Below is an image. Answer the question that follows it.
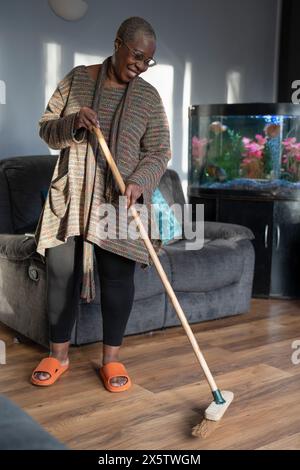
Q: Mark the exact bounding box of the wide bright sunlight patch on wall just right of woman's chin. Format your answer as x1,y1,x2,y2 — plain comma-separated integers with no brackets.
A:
141,64,174,142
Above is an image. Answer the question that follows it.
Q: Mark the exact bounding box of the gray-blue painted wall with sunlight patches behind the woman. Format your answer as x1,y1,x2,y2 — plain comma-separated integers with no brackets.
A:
0,0,278,194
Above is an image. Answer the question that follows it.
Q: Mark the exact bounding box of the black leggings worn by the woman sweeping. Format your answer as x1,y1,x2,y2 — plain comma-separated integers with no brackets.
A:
46,236,135,346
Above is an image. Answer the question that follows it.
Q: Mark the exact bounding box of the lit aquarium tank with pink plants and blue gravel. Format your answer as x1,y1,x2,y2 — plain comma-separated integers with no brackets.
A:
189,103,300,196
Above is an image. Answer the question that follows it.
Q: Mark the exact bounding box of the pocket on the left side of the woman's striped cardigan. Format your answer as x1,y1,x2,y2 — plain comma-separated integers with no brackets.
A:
49,173,71,219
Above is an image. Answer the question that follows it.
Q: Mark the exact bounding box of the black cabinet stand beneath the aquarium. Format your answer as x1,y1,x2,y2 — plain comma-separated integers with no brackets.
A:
189,188,300,299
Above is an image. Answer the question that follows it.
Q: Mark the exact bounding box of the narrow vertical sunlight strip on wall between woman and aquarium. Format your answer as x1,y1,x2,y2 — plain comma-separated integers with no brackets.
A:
181,62,192,175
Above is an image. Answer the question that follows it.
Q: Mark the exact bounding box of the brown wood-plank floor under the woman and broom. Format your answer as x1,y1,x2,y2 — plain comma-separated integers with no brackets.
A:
0,299,300,450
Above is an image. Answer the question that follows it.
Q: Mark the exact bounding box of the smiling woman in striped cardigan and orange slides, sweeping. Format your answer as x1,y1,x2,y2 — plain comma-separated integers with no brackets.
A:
31,17,170,392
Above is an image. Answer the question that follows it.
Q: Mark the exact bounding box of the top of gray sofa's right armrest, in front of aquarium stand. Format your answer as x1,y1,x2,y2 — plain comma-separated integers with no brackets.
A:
204,222,255,242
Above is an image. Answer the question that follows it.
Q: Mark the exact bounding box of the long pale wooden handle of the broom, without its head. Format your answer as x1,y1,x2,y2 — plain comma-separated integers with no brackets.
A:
93,127,218,392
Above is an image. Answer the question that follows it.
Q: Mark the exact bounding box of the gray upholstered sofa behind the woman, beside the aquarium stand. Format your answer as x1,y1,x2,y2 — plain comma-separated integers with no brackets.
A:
0,155,254,345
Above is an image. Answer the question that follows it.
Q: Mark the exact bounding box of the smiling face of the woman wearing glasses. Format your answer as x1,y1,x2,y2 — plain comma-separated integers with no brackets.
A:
113,32,156,83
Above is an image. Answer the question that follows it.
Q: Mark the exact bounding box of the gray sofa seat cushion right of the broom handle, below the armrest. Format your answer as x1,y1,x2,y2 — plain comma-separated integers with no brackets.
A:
163,240,244,292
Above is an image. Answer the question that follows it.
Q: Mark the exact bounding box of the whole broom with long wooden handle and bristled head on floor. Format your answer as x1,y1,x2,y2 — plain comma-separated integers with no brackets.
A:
93,127,233,437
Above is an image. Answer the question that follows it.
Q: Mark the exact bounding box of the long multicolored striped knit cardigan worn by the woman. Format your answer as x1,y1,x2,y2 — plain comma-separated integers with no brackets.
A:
35,60,170,302
